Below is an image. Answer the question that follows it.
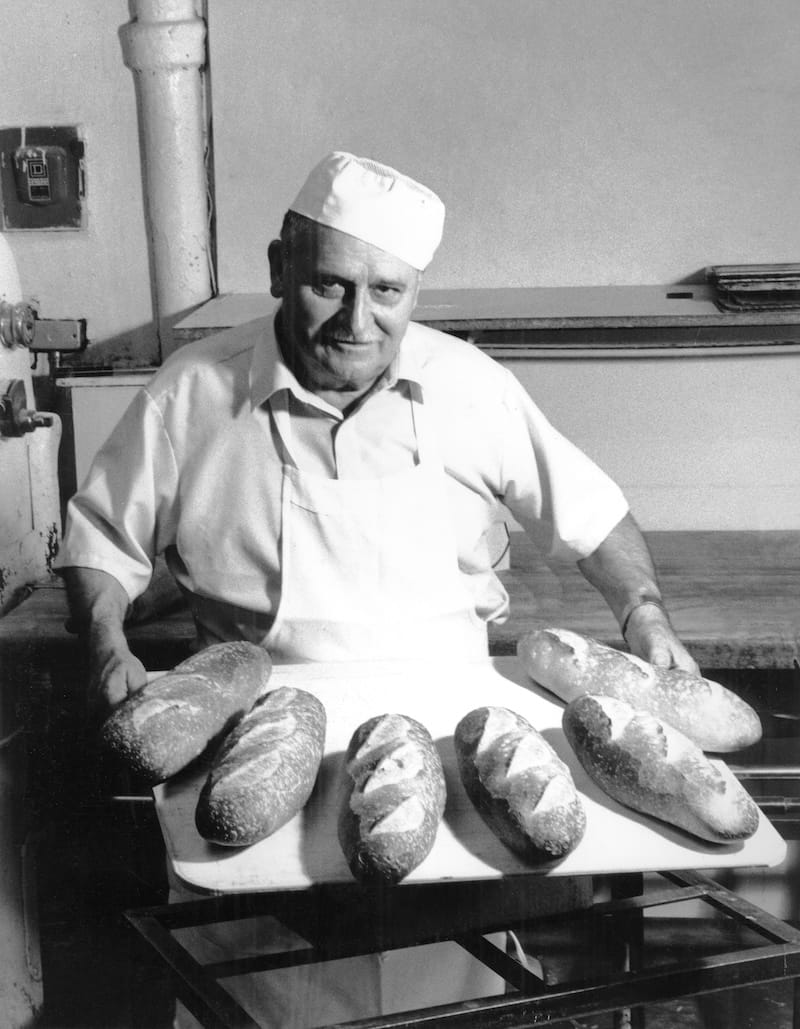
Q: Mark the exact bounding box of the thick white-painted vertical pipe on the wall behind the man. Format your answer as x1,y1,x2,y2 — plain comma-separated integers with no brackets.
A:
119,0,211,357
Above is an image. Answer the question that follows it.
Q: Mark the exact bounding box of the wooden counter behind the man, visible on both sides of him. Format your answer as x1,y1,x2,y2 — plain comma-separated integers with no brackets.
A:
0,532,800,677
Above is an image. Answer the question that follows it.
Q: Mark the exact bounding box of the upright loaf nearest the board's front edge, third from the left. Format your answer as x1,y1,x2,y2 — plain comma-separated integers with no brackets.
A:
339,714,446,883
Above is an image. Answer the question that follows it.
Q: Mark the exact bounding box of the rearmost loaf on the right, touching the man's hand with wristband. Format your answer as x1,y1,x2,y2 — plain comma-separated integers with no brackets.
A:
517,629,761,753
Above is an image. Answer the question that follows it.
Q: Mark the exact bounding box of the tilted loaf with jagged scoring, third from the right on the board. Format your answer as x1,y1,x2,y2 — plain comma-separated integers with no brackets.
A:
453,707,586,864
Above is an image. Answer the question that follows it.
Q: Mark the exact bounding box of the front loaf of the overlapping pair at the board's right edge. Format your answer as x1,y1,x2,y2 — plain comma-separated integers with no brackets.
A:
562,695,759,843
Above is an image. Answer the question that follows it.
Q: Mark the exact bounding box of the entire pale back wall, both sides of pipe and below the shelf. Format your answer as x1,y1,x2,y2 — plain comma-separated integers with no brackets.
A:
7,0,800,528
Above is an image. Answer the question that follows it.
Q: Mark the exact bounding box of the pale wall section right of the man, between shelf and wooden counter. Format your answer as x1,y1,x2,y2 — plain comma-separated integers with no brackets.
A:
509,354,800,530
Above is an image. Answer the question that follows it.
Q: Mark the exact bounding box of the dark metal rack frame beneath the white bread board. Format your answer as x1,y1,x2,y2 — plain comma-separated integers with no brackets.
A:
126,872,800,1029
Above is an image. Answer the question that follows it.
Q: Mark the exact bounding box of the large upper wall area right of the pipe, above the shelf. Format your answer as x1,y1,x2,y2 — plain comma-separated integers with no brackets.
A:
209,0,800,292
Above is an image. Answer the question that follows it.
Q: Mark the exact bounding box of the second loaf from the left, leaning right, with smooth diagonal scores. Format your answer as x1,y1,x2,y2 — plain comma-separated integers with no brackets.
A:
195,686,326,847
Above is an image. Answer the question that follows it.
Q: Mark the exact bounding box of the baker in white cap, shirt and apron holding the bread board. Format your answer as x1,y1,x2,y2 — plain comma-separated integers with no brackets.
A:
58,152,696,1025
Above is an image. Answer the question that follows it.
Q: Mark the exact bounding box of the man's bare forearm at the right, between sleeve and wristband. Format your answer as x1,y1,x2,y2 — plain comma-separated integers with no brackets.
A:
578,515,661,625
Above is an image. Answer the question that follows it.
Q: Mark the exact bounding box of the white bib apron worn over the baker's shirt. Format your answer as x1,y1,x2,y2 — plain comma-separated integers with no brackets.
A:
264,394,487,663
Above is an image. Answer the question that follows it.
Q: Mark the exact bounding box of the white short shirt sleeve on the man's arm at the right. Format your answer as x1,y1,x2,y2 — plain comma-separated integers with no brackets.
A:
501,376,628,561
